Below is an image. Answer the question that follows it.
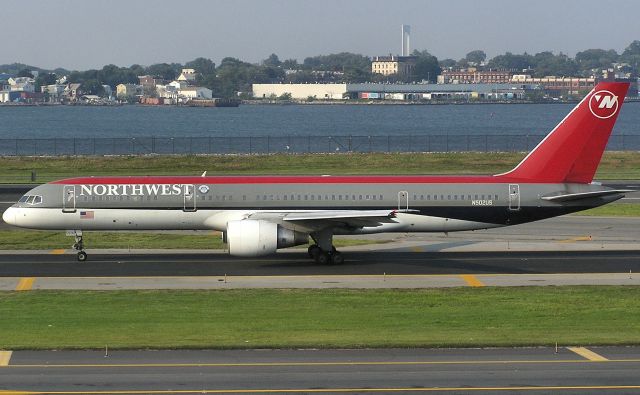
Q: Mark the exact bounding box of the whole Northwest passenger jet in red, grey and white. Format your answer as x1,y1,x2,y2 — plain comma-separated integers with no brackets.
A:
2,82,632,264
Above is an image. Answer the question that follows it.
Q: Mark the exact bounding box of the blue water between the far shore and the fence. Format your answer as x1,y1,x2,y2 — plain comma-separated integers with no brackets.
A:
0,102,640,139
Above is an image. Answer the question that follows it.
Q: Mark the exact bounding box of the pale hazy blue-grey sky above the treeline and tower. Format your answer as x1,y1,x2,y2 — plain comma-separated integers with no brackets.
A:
5,0,640,70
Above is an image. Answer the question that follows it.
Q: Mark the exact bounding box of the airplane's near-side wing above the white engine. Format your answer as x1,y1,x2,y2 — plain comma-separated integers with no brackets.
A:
247,210,406,230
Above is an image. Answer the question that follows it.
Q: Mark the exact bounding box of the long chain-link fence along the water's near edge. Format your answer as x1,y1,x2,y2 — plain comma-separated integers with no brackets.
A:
0,134,640,156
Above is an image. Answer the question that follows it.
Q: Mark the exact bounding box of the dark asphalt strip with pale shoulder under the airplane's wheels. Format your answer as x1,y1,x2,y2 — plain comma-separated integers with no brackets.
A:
0,251,640,290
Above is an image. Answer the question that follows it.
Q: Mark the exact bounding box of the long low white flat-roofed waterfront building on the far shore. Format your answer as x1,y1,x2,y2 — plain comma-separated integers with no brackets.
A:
253,83,536,101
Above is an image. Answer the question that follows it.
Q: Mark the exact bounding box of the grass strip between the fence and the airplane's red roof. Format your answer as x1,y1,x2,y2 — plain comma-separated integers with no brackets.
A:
0,152,640,183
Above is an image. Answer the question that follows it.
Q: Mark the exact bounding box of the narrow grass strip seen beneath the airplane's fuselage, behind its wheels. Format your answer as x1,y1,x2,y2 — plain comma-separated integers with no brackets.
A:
0,230,380,250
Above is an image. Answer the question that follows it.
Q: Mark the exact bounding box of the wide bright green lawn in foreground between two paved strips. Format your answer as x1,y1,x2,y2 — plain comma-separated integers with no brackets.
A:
0,286,640,350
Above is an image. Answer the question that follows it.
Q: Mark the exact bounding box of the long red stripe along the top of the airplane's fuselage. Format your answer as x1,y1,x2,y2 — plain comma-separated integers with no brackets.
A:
51,176,531,185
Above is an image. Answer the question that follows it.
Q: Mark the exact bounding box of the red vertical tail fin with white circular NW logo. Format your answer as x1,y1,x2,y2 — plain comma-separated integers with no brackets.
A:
500,82,629,183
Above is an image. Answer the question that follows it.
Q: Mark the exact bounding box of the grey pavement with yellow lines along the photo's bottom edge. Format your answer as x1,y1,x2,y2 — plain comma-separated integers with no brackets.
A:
0,347,640,395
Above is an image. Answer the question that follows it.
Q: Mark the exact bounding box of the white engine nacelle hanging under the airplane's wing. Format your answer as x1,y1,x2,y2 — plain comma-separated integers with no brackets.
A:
226,219,309,257
